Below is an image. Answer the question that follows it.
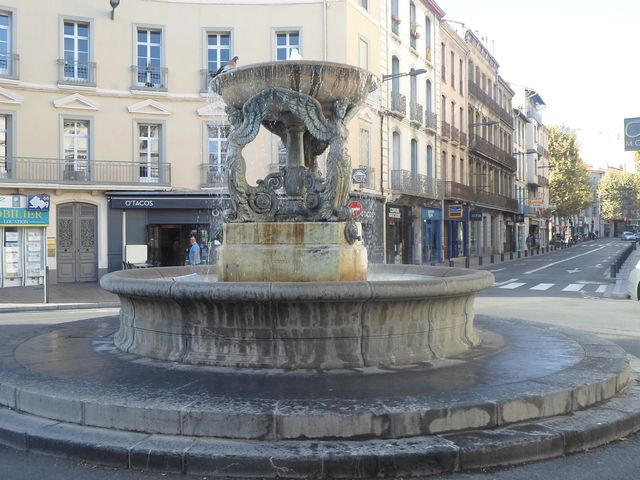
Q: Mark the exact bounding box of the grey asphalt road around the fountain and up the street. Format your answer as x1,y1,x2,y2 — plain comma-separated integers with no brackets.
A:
0,249,640,480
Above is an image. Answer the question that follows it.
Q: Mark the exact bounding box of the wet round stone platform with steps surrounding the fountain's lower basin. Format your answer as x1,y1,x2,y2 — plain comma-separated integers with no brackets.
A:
0,317,640,478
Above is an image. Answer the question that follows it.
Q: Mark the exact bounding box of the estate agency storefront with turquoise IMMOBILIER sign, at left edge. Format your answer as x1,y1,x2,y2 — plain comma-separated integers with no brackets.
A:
0,194,51,288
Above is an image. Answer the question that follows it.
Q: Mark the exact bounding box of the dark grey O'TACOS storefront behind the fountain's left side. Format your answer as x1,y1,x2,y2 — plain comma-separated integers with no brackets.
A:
107,192,231,271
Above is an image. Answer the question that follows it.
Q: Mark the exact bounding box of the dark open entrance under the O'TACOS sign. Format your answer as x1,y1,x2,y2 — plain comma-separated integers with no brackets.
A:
147,224,211,267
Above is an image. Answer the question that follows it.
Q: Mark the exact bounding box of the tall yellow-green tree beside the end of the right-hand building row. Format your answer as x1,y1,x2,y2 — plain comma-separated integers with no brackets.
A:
549,125,593,217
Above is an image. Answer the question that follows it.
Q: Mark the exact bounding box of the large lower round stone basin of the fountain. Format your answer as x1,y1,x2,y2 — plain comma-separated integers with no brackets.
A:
100,265,493,370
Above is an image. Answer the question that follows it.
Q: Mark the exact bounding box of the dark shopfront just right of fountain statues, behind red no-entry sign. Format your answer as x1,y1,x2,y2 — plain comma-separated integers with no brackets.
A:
348,195,384,263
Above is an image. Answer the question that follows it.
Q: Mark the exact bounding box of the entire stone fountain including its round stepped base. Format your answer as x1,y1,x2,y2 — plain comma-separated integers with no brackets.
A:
0,61,640,479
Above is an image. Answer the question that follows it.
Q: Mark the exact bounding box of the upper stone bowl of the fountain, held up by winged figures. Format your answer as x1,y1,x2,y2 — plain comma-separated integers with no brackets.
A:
211,60,379,109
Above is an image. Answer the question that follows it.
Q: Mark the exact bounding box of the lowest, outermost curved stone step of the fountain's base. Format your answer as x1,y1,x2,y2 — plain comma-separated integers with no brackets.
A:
0,381,640,479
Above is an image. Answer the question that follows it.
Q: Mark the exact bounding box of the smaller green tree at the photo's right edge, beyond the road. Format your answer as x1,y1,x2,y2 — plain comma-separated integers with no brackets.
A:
598,170,640,220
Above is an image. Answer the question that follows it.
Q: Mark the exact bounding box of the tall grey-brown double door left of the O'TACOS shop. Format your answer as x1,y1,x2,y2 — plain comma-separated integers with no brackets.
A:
56,203,98,283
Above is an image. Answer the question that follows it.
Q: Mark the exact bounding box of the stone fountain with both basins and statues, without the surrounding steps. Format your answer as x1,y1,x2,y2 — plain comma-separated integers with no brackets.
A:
102,61,493,370
